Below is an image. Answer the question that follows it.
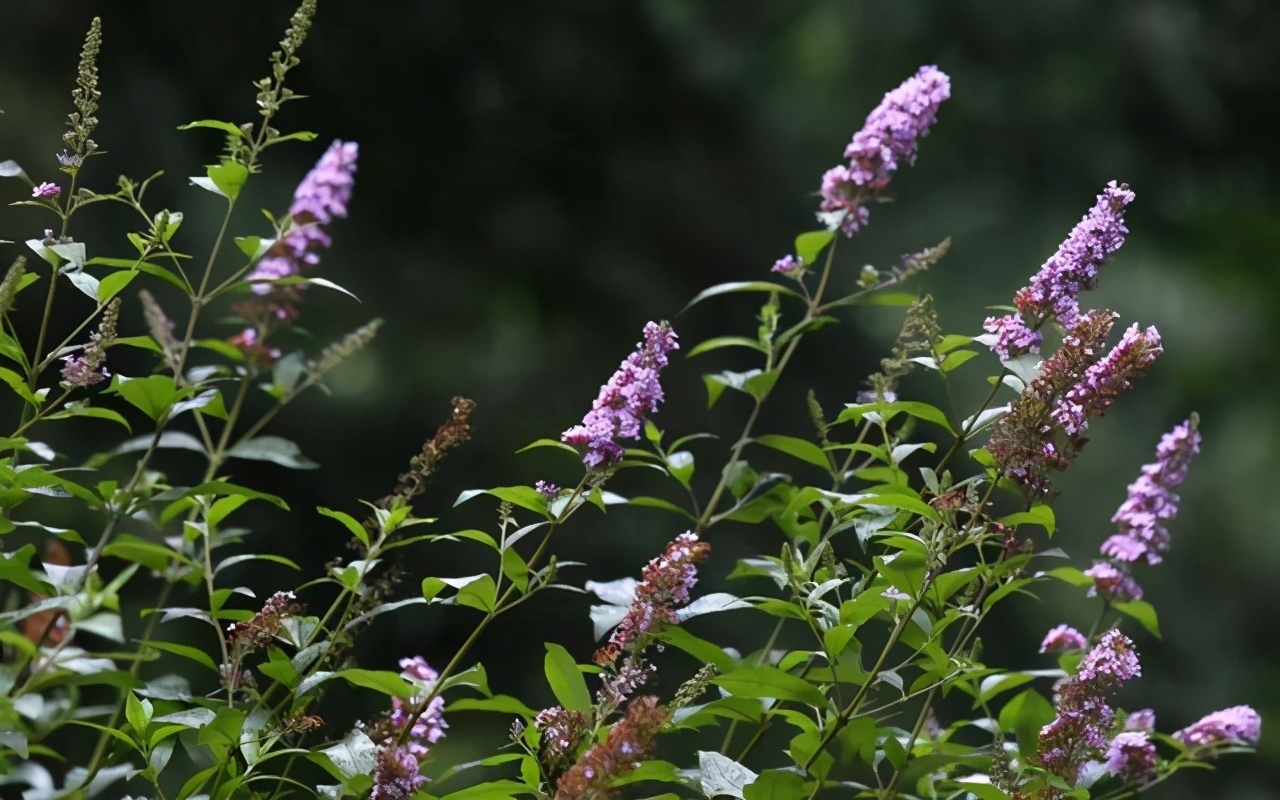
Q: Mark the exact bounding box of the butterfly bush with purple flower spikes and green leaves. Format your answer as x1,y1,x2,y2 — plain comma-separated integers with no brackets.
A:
0,0,1261,800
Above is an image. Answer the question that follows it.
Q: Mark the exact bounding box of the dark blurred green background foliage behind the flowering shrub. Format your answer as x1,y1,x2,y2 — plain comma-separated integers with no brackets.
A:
0,0,1280,797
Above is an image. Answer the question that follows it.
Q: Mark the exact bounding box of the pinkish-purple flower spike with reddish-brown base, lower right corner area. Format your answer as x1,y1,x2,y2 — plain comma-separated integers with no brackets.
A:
1036,630,1142,797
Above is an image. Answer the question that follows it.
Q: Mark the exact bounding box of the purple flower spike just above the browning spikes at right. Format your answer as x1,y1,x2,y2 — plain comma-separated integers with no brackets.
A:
1014,180,1134,330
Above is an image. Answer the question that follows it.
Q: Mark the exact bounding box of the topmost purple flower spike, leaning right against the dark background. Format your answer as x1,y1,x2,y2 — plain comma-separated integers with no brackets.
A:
819,65,951,234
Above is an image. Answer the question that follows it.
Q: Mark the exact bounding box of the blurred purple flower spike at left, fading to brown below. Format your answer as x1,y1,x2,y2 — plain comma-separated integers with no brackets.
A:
234,140,360,356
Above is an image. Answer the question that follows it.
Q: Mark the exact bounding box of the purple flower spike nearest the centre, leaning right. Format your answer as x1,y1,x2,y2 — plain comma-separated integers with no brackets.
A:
561,323,680,470
